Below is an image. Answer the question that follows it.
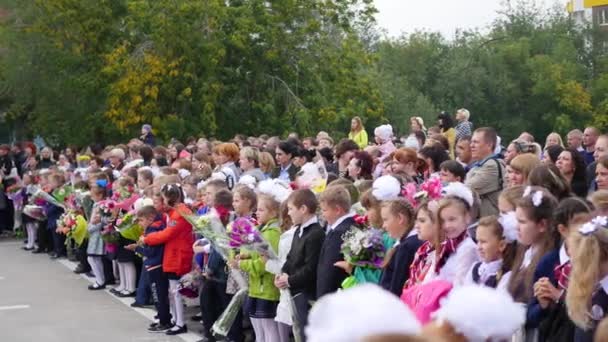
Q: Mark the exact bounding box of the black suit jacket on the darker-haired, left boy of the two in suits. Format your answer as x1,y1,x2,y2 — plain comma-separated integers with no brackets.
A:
282,223,325,298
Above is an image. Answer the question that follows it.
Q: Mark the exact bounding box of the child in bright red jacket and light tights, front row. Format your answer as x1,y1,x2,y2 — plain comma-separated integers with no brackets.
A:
140,184,194,335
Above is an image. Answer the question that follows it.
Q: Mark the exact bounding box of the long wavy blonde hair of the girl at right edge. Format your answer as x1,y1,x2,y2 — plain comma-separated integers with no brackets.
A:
566,227,608,329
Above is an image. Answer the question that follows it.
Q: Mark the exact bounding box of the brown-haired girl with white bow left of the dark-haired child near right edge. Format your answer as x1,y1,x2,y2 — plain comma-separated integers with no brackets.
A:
508,187,558,303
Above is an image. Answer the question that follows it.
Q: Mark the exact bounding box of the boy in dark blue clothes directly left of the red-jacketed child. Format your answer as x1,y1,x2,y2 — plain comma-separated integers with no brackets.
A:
125,206,171,332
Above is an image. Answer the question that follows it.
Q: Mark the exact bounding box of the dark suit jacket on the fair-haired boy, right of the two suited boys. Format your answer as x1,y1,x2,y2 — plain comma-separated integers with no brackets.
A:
317,217,355,299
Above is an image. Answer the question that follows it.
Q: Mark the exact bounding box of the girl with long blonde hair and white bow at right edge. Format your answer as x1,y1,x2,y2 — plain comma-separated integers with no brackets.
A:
566,216,608,342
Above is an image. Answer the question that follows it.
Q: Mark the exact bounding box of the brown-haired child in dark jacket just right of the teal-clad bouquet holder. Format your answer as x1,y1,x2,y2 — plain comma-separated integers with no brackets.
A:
380,199,422,296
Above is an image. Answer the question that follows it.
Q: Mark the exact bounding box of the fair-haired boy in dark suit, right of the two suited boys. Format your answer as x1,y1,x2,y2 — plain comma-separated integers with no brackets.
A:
317,186,355,299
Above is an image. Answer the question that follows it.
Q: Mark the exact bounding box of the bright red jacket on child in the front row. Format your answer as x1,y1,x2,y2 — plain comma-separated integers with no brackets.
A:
144,204,194,276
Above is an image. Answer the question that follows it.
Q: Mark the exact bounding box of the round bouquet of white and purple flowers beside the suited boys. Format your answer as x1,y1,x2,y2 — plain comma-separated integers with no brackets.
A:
341,227,386,268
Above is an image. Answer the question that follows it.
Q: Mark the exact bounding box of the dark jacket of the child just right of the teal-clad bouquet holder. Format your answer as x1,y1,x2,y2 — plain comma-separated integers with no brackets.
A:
380,230,422,297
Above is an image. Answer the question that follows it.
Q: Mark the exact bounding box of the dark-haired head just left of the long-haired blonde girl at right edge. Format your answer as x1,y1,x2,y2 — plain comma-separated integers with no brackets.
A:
553,197,592,243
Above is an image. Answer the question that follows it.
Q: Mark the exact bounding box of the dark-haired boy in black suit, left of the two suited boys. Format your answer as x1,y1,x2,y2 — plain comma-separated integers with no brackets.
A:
275,190,325,341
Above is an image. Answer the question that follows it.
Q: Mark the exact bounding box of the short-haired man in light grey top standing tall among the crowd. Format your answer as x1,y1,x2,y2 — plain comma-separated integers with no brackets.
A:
465,127,505,217
